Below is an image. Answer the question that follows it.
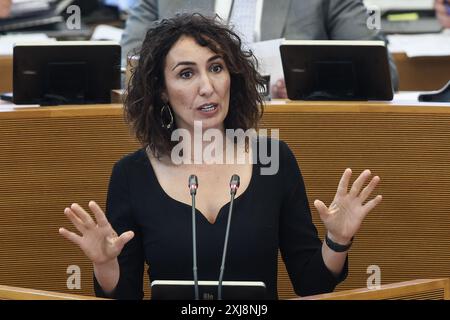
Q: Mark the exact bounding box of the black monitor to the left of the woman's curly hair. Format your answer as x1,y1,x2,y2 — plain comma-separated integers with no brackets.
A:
13,41,121,105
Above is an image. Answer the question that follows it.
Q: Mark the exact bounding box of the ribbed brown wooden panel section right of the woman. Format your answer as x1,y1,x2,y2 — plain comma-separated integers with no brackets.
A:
264,112,450,294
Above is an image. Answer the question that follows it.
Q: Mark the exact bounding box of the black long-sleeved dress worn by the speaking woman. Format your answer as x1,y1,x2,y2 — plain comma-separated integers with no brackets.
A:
94,141,348,299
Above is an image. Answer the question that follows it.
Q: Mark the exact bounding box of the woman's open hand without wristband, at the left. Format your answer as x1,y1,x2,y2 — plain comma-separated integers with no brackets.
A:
59,201,134,265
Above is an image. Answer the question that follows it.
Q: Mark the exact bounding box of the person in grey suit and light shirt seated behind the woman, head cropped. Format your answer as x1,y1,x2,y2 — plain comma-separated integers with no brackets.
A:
121,0,398,98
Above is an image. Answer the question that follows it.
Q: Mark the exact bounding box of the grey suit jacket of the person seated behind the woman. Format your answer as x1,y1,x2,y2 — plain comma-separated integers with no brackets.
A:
122,0,398,89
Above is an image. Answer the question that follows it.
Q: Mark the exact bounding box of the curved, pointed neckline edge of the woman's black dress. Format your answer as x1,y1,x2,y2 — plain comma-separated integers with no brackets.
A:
141,148,257,226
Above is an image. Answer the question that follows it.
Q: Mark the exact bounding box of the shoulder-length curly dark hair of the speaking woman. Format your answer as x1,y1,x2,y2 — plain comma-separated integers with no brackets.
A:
124,13,264,157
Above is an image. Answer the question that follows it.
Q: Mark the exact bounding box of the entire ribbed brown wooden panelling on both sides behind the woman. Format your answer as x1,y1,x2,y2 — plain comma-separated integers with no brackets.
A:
0,103,450,298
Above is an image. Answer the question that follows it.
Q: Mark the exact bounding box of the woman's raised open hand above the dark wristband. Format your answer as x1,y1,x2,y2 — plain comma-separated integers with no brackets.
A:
314,169,382,244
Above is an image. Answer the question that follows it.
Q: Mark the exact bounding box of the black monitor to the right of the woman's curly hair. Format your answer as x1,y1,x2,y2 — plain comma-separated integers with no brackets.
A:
280,40,393,100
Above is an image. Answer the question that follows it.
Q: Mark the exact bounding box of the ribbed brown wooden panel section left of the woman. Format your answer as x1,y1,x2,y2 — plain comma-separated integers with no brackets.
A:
0,117,142,294
